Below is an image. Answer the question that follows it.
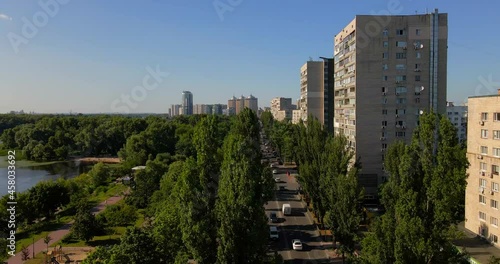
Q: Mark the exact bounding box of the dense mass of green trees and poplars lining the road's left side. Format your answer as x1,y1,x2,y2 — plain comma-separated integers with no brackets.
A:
82,109,276,264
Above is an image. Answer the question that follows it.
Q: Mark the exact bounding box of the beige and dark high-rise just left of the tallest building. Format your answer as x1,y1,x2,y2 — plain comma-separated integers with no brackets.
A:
298,58,334,132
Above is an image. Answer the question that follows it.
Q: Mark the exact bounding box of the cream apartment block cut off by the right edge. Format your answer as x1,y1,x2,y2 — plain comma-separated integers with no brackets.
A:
465,89,500,248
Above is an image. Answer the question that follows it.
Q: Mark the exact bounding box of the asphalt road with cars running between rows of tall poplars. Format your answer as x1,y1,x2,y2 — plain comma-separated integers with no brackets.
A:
265,169,341,264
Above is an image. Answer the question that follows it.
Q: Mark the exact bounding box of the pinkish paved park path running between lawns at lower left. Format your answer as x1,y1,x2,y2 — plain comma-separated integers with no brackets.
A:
6,196,123,264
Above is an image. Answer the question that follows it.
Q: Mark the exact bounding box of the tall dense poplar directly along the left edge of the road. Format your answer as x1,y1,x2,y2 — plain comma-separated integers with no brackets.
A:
216,134,268,264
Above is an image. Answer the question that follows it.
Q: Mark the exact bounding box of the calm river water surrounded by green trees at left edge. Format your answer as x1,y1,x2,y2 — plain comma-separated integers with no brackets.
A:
0,156,94,196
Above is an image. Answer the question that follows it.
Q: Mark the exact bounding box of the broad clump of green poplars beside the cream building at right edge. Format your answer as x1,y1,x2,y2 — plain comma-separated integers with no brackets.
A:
363,113,469,263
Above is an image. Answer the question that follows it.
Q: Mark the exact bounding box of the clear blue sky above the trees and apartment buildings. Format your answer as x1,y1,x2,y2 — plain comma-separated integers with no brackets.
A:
0,0,500,113
